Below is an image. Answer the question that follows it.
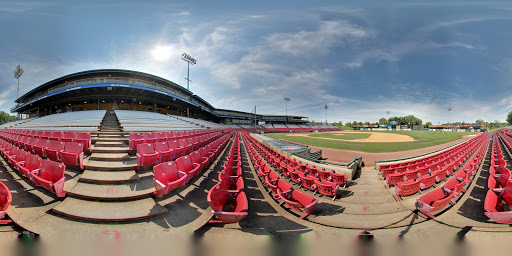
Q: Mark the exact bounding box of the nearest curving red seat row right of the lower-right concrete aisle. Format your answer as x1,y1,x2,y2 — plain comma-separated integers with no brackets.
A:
416,133,490,218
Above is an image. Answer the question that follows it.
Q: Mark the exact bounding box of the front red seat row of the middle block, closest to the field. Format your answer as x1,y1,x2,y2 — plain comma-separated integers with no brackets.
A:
244,132,347,200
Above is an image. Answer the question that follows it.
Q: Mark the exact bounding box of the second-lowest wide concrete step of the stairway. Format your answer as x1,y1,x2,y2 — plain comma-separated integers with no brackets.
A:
68,176,155,201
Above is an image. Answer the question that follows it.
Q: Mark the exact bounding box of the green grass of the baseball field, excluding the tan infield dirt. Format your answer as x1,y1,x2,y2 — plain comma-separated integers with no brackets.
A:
266,131,477,153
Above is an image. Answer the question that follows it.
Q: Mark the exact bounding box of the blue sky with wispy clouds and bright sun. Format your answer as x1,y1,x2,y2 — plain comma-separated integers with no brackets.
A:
0,0,512,124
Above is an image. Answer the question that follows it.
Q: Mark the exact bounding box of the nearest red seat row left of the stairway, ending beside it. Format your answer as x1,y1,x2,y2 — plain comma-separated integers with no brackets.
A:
0,140,66,197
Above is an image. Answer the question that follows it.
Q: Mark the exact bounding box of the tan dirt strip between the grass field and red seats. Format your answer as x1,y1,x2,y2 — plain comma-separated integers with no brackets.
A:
309,135,469,166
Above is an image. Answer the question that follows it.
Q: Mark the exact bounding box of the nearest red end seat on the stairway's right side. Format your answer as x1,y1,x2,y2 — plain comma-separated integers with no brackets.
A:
153,161,188,198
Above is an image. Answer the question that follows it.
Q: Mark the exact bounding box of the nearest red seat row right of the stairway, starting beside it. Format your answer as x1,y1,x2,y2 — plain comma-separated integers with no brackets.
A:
153,131,233,198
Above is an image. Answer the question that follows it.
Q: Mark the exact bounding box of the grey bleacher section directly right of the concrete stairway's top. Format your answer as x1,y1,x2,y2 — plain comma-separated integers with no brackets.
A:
115,110,226,132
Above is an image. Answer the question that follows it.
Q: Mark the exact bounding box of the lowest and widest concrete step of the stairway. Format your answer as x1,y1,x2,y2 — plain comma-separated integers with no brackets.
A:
52,197,167,222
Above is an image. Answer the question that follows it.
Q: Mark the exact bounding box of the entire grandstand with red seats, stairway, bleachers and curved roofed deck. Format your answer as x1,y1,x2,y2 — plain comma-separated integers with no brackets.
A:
0,70,512,249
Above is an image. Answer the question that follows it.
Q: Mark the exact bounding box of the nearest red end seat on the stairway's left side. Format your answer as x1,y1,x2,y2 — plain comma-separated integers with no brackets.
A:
32,160,66,197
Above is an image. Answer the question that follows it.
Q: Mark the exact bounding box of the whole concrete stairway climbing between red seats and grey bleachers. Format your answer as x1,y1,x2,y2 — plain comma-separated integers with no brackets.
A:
53,112,167,221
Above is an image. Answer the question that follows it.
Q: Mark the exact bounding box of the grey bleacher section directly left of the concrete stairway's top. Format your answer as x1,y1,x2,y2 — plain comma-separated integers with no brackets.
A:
2,110,106,131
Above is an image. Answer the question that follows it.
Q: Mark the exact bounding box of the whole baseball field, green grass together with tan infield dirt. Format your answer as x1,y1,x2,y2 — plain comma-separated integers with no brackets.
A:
267,131,477,153
